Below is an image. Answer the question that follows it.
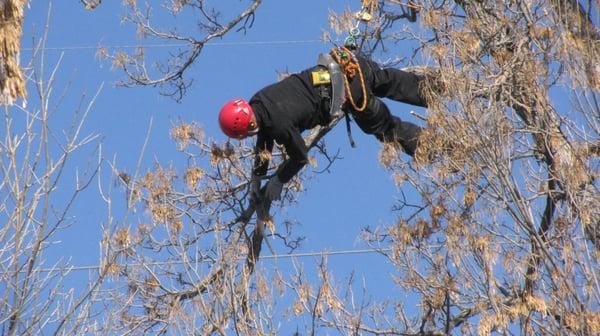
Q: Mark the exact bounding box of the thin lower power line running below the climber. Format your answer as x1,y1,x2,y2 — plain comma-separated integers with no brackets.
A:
7,248,392,275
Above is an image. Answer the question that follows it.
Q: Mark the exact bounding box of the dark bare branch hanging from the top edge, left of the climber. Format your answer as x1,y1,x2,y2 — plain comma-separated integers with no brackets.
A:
99,0,262,100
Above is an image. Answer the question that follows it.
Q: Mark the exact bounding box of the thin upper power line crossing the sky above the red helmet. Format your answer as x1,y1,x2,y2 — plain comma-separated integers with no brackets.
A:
21,39,326,51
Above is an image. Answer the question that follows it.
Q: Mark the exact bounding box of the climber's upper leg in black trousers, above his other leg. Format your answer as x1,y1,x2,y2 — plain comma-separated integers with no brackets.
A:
363,58,427,107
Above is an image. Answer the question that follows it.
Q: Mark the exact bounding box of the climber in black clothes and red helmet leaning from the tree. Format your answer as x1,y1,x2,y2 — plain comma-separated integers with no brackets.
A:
219,49,427,201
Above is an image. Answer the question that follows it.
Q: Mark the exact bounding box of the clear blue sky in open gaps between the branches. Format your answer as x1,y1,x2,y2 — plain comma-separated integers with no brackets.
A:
22,0,426,316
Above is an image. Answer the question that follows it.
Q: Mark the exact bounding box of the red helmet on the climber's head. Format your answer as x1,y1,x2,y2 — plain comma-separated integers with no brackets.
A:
219,98,254,139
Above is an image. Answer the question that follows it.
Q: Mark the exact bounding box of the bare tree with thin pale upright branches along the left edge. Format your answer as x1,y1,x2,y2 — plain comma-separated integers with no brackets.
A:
0,20,106,335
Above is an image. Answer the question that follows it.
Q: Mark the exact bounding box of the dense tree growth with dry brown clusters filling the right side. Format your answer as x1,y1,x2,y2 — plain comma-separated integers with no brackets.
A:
324,1,600,335
